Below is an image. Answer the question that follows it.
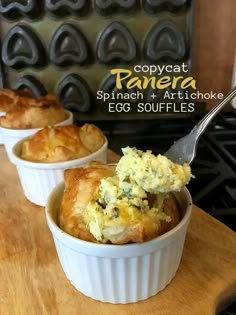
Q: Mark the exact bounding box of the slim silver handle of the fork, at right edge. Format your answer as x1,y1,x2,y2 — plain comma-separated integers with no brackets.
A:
191,86,236,138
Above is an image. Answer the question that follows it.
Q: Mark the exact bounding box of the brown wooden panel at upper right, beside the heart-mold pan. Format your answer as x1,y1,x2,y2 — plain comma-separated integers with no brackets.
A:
192,0,236,110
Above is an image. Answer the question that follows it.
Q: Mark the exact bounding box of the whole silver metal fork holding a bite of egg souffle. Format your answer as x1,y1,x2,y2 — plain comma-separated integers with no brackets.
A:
164,87,236,164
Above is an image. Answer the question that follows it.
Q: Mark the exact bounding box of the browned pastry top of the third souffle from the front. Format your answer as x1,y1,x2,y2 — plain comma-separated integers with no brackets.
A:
0,94,66,129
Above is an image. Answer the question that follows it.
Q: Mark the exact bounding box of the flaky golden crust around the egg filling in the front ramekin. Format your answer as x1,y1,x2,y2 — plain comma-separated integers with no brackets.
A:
59,163,180,244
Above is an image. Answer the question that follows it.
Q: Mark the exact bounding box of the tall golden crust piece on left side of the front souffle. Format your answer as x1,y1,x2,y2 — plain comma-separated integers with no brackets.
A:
59,162,114,243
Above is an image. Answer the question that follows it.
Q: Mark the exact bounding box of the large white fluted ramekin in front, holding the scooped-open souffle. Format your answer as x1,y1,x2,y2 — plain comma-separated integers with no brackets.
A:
46,182,192,304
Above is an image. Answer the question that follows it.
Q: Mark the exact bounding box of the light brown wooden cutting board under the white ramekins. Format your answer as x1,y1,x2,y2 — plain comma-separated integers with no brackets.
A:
0,147,236,315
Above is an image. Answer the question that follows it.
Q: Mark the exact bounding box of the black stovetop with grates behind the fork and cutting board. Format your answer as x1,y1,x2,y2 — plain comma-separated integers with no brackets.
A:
90,111,236,231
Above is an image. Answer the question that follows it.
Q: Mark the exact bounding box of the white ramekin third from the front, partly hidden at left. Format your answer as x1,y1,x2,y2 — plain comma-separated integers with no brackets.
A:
1,110,73,163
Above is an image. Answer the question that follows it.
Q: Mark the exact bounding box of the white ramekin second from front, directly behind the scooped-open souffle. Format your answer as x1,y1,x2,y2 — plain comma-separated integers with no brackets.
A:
12,138,108,207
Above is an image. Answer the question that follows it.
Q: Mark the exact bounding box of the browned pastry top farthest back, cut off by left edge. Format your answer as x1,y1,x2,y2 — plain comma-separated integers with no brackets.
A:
0,89,32,112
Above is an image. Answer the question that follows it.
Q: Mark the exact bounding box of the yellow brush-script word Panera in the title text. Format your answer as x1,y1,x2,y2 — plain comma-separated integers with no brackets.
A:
111,69,196,90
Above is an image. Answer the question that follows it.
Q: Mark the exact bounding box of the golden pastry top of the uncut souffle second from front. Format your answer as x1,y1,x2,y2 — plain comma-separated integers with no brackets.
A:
21,124,105,163
